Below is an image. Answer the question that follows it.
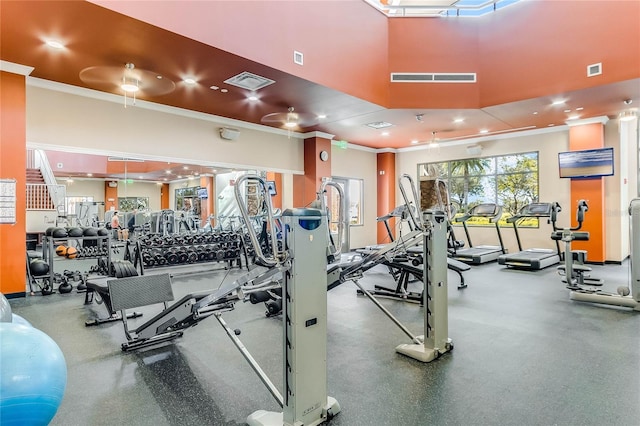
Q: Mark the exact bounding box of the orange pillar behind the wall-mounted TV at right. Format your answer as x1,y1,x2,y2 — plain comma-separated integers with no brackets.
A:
569,118,606,263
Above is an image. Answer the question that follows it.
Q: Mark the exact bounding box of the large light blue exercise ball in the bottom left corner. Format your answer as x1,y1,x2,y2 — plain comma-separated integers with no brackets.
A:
0,322,67,426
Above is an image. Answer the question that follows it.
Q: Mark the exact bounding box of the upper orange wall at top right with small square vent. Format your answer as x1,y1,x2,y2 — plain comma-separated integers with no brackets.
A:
478,1,640,106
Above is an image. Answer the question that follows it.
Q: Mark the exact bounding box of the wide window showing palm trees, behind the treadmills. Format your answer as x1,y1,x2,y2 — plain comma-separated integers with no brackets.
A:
418,152,538,227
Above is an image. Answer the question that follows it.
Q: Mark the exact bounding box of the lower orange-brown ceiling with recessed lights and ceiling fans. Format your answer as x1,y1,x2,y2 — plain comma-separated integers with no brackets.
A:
0,0,640,181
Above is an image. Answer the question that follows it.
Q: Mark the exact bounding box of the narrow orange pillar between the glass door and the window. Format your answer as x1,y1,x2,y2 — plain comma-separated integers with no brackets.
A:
377,152,396,244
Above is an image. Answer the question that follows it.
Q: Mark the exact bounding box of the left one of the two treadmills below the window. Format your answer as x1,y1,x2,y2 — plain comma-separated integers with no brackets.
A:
452,203,506,265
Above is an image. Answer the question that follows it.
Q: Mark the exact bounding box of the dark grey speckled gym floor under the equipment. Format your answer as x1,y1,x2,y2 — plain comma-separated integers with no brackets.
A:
11,255,640,426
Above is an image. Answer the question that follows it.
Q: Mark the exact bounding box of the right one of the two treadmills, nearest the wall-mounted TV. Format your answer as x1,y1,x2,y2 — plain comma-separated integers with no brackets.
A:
498,203,560,270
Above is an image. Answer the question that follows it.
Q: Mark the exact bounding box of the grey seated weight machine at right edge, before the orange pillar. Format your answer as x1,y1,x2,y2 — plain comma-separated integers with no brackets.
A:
553,198,640,311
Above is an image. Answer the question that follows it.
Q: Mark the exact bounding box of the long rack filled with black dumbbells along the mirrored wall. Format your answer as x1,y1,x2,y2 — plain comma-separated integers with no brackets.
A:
130,232,248,275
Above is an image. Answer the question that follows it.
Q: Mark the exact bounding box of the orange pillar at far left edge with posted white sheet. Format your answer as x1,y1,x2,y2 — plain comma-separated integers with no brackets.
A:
0,71,27,298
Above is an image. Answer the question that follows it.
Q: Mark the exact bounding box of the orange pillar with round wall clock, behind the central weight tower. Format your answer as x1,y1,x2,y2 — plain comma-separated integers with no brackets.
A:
293,136,331,207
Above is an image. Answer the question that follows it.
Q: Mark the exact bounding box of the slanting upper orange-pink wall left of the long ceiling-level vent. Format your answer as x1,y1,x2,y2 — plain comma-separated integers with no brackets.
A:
92,0,389,104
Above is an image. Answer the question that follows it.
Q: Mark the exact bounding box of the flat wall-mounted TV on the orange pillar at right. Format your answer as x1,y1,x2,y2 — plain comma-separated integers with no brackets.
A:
558,148,613,179
